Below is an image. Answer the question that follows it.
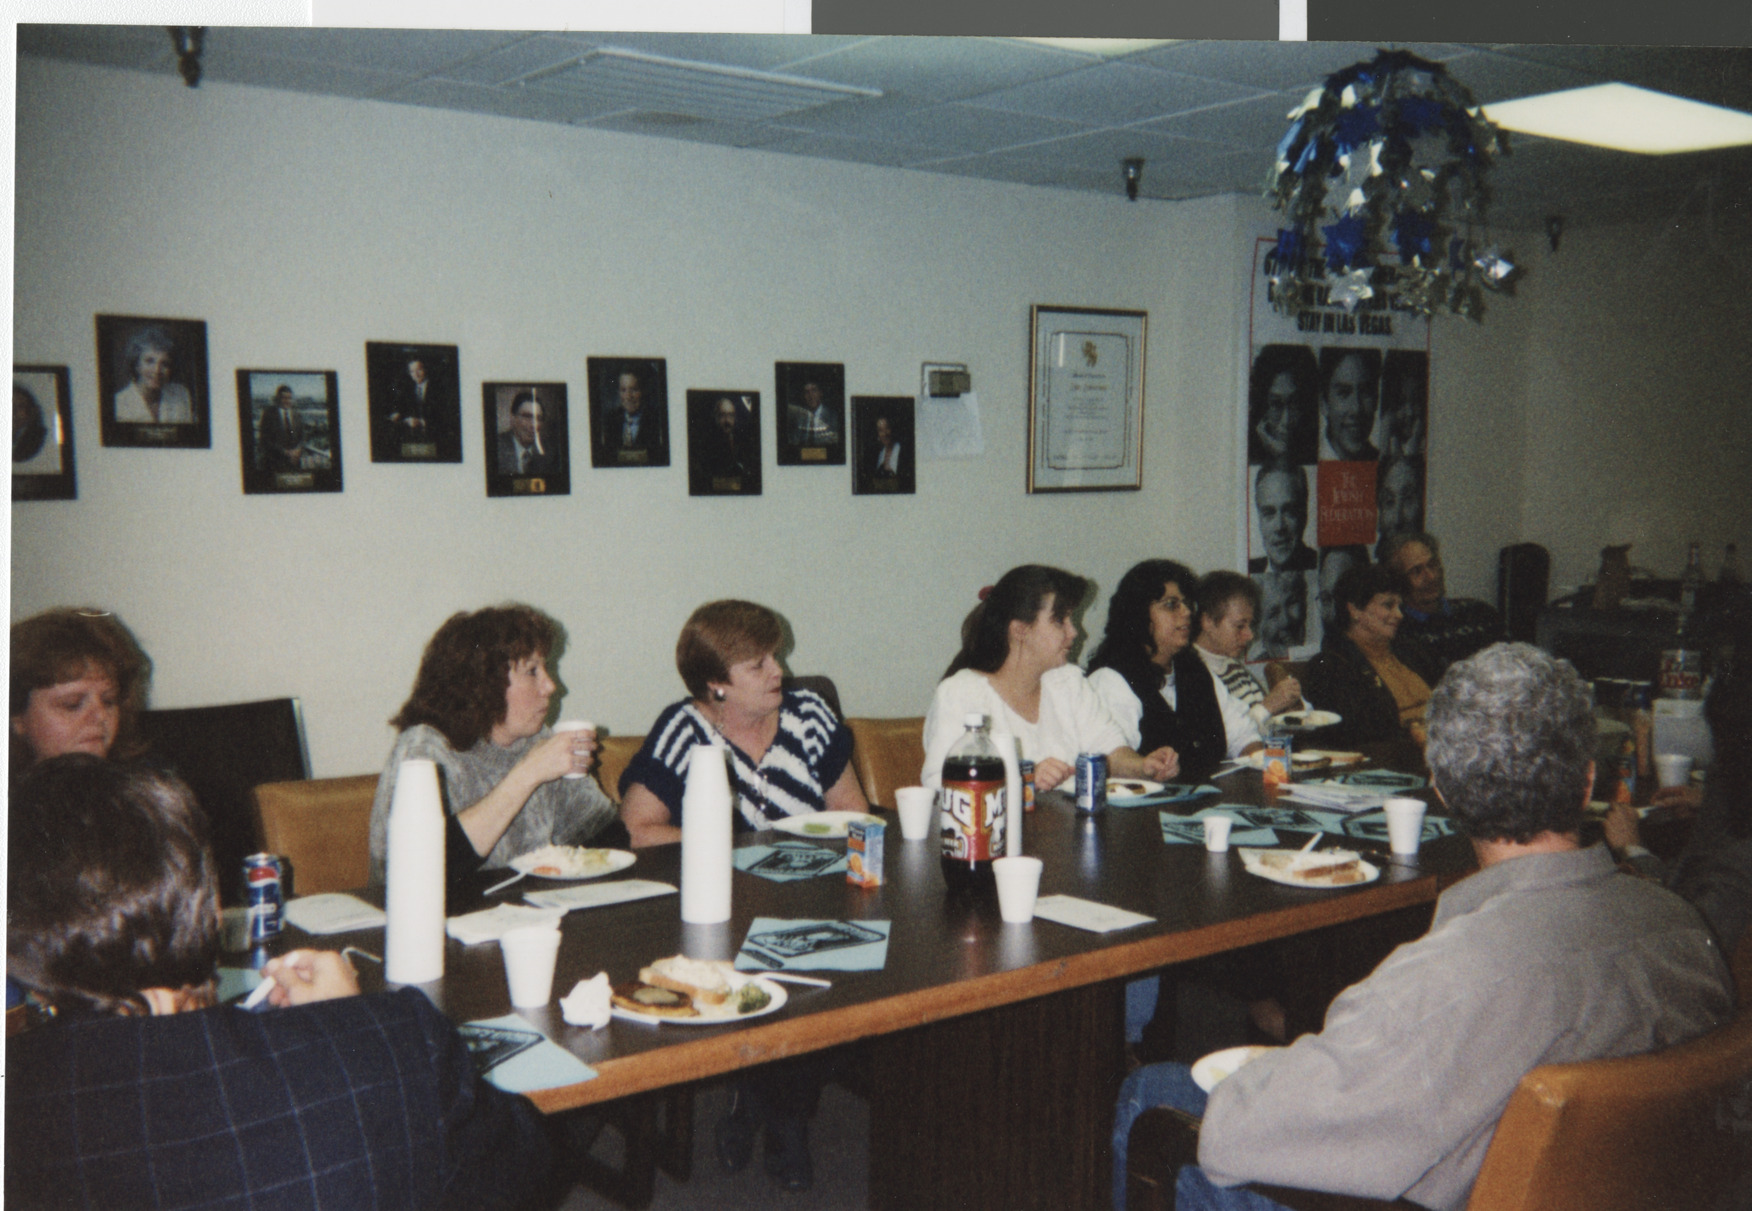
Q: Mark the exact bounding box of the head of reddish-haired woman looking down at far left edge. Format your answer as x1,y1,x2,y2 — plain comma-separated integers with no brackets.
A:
11,608,152,778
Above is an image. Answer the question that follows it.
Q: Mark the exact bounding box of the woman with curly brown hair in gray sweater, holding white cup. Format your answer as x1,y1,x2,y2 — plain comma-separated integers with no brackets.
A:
371,605,622,883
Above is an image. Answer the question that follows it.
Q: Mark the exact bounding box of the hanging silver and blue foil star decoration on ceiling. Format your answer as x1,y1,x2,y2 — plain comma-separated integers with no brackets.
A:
1267,51,1515,321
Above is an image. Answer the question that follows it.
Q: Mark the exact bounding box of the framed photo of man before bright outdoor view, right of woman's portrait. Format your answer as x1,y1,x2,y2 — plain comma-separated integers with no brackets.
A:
237,370,340,496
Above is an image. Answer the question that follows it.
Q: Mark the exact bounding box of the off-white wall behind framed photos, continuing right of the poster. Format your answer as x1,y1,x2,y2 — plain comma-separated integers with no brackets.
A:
12,60,1752,775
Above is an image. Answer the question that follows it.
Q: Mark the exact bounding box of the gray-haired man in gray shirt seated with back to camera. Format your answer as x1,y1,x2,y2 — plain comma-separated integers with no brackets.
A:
1113,643,1733,1211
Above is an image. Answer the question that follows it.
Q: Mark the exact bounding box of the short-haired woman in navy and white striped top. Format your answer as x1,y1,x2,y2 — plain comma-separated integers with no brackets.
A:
620,601,869,846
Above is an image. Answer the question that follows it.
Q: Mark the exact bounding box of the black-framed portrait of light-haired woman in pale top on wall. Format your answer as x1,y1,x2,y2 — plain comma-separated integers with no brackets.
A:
96,315,212,450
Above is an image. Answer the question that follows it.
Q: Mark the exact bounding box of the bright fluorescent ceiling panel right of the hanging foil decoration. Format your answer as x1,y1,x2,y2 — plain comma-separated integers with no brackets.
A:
1484,84,1752,156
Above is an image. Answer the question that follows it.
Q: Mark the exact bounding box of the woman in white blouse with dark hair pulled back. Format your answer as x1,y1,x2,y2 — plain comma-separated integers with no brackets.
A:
920,564,1179,790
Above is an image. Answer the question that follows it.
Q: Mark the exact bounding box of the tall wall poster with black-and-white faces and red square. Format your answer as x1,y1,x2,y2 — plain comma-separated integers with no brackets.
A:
1244,237,1430,661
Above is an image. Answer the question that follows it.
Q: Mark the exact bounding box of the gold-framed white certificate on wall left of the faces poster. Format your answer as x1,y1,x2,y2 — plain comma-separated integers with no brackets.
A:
1028,305,1149,492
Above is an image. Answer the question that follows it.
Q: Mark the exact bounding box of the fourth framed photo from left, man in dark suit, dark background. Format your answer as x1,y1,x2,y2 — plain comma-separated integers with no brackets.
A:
364,340,463,463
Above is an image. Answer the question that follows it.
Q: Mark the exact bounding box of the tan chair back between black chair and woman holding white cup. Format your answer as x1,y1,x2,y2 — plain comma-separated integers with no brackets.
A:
254,773,377,896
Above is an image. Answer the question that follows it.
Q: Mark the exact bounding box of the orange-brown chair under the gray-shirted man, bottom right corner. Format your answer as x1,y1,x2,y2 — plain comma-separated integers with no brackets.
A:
1127,936,1752,1211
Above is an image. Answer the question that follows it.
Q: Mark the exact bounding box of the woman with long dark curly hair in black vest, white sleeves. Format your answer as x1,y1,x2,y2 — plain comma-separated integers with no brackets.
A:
1090,559,1260,782
